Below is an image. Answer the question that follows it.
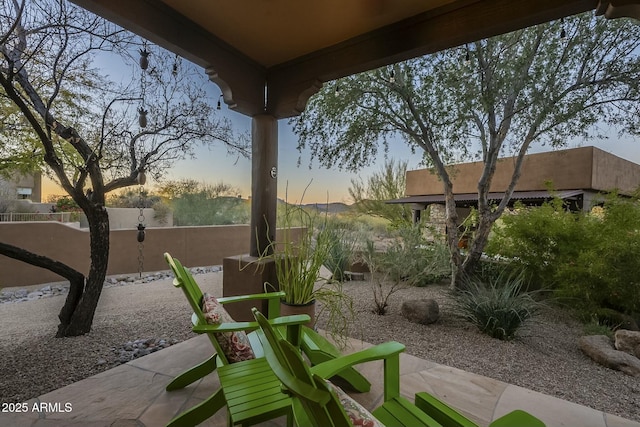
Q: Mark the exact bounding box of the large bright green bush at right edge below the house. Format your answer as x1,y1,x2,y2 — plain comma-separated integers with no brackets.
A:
487,194,640,318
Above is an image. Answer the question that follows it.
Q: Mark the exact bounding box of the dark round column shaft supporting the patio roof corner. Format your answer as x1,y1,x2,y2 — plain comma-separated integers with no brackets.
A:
249,114,278,257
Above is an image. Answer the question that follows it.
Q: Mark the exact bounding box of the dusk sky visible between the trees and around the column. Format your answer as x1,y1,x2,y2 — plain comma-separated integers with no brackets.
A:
43,46,640,204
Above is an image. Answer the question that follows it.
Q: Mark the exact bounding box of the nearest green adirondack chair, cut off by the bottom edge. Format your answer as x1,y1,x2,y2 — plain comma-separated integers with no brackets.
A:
253,308,544,427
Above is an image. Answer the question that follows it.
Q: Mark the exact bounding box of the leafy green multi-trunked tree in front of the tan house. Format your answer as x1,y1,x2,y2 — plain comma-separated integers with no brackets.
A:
294,14,640,286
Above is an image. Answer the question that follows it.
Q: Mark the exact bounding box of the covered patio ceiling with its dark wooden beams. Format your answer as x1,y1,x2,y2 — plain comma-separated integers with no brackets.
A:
67,0,640,119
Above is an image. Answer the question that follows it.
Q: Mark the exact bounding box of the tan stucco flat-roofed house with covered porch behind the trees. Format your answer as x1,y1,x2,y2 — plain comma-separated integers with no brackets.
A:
388,147,640,226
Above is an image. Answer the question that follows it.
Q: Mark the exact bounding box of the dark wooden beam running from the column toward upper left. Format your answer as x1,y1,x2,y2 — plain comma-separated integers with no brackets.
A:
71,0,266,116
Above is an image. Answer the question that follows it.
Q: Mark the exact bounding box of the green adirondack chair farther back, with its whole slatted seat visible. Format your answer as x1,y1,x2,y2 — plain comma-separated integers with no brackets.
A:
164,253,370,427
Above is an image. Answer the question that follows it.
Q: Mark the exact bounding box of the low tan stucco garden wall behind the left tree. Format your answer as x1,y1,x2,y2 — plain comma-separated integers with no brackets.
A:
0,222,301,286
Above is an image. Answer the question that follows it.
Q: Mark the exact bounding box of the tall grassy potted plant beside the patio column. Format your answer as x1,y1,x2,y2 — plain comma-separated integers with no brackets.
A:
271,203,353,348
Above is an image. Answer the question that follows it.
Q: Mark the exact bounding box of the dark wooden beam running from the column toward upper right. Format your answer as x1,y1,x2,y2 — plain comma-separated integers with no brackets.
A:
267,0,597,118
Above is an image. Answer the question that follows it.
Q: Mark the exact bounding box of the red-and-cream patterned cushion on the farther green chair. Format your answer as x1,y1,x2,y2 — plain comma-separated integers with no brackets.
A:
202,293,256,363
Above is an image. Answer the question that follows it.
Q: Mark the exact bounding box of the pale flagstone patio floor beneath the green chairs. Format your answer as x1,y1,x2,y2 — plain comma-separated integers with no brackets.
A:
0,336,640,427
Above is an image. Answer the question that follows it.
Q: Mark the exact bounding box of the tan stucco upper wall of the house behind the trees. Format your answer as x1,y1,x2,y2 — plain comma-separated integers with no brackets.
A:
406,147,640,196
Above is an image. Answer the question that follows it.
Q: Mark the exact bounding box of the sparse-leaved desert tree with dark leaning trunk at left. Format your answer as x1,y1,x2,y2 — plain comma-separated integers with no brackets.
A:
0,0,247,336
